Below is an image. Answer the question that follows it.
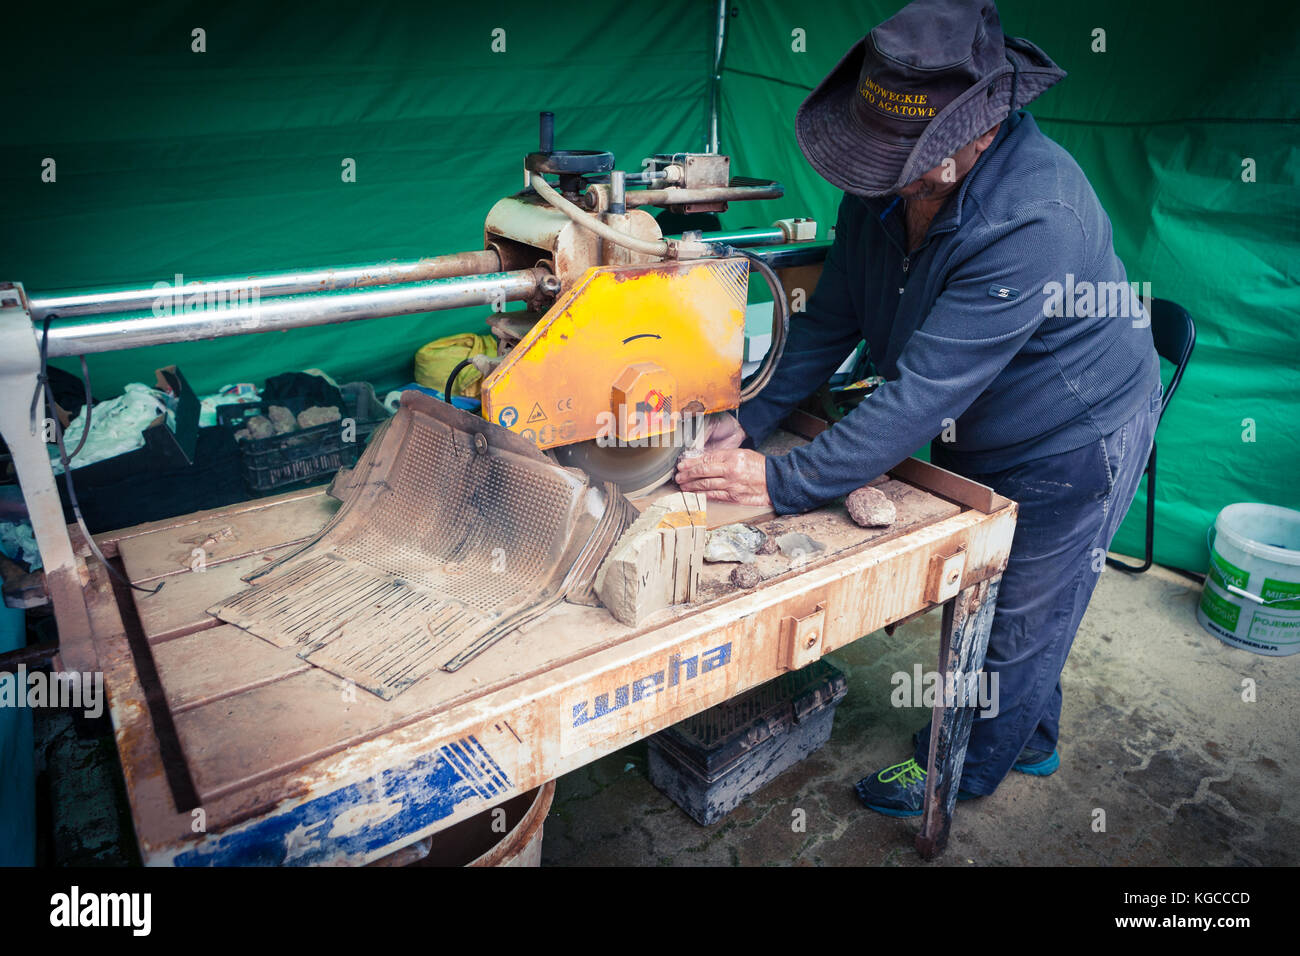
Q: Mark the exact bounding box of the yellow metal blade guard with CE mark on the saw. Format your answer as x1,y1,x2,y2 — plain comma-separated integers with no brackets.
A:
482,256,749,449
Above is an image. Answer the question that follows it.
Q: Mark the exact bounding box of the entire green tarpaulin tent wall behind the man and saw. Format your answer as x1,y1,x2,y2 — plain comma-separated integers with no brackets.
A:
0,0,1300,570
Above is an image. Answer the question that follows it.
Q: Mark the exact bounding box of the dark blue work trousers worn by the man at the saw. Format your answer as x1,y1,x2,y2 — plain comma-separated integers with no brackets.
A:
915,388,1161,796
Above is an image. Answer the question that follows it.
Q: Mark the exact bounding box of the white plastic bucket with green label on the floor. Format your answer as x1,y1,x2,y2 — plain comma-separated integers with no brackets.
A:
1196,503,1300,657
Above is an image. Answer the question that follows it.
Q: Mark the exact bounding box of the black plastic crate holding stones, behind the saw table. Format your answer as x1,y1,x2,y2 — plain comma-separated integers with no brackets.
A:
217,382,389,493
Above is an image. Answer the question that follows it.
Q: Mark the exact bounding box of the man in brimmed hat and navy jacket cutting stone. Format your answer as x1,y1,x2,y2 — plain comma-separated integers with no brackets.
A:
677,0,1161,816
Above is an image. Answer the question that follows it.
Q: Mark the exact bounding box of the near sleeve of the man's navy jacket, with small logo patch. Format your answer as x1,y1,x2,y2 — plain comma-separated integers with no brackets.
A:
767,203,1086,514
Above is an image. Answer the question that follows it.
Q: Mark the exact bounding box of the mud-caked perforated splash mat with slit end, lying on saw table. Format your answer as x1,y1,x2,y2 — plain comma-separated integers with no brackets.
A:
209,392,634,698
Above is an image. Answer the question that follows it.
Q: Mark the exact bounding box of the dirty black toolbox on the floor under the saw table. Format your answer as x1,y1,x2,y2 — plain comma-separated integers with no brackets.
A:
647,661,848,825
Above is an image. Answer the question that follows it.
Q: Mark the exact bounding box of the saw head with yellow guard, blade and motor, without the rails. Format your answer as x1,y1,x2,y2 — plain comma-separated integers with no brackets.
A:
467,113,815,494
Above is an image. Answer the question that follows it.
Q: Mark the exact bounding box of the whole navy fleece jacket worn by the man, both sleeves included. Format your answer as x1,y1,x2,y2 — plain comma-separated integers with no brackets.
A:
740,112,1160,514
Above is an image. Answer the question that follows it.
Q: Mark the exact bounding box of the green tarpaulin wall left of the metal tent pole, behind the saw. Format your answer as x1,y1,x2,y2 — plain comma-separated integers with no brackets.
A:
0,0,715,395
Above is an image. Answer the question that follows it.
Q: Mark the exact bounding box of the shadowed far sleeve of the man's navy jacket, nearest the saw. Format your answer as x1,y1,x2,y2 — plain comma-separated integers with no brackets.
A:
738,199,862,447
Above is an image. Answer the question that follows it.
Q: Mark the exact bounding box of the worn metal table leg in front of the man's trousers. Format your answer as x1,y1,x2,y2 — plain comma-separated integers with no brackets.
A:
917,575,1002,860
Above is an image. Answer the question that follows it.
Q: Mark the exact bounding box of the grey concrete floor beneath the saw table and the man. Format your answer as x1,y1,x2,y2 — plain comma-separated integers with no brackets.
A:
542,568,1300,866
